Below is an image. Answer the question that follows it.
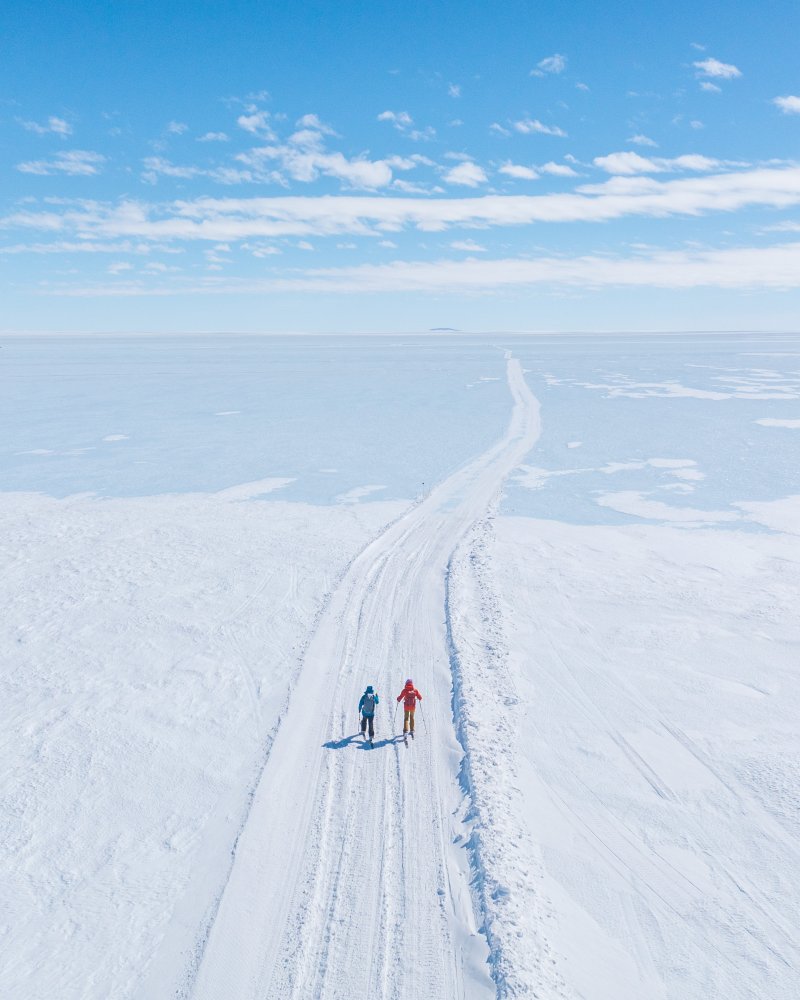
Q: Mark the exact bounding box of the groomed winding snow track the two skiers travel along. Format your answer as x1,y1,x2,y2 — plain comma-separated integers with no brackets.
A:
191,352,539,1000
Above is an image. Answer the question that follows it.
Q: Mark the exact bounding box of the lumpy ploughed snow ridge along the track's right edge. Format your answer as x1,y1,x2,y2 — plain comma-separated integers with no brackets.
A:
445,512,567,1000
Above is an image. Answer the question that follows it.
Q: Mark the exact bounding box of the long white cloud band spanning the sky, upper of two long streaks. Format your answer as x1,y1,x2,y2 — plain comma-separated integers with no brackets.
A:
9,164,800,247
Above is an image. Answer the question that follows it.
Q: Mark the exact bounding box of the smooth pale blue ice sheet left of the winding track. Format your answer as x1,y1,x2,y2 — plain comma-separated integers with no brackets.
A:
0,337,508,504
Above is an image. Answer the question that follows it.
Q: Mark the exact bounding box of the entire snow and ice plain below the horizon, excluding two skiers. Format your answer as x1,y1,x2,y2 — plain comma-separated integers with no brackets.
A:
0,335,800,1000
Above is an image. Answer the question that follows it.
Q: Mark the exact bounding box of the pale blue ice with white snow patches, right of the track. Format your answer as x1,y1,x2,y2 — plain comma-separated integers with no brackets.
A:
502,335,800,530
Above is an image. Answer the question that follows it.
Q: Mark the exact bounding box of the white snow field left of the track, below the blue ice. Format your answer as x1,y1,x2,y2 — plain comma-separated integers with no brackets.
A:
0,489,404,1000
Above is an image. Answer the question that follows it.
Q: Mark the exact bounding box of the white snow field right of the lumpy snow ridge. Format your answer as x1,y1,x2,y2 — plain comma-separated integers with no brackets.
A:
494,518,800,1000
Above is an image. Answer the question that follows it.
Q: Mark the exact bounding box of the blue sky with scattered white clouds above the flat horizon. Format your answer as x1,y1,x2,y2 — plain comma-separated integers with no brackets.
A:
0,0,800,332
